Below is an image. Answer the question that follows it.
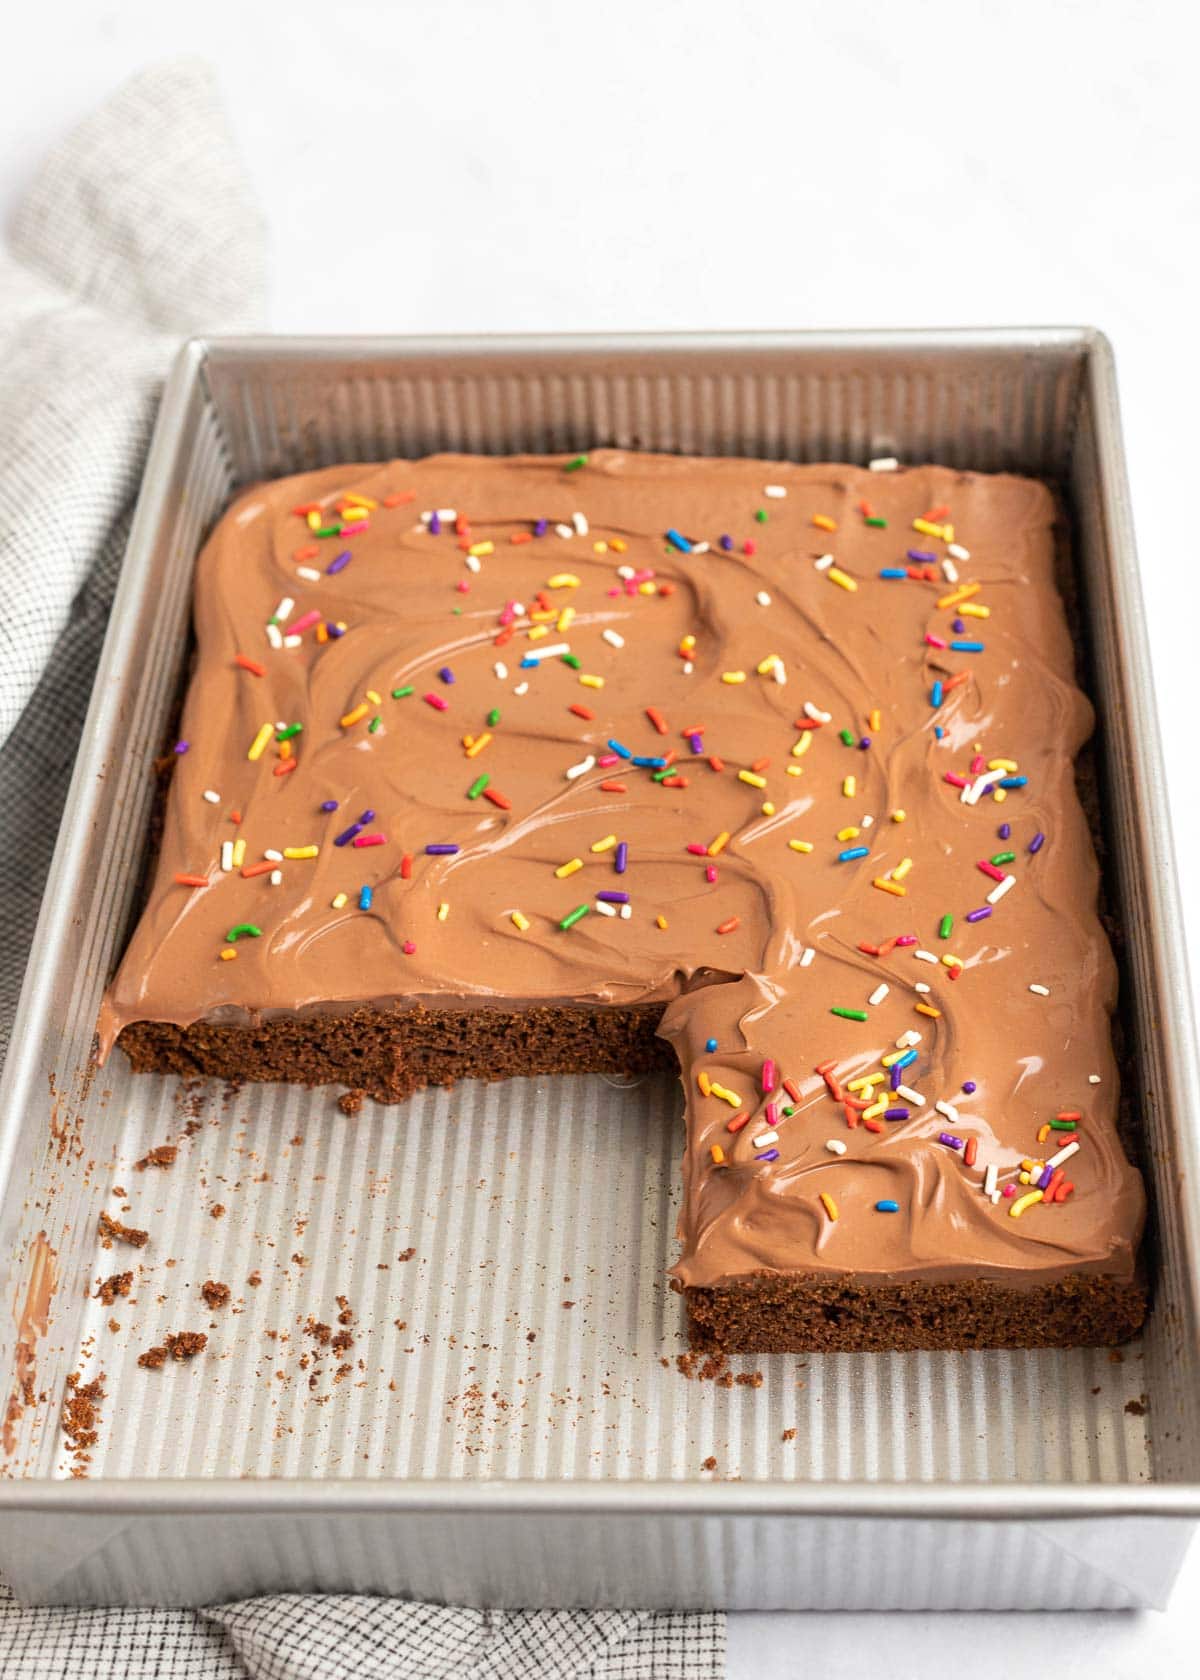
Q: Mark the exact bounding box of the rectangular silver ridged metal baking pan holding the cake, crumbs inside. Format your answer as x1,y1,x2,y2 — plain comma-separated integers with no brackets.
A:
0,329,1200,1609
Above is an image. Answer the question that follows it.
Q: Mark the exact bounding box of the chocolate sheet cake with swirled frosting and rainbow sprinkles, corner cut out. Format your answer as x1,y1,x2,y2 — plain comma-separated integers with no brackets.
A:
101,450,1145,1352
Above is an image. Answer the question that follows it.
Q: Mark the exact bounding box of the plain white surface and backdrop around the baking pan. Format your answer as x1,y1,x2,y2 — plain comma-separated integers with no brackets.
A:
0,0,1200,1680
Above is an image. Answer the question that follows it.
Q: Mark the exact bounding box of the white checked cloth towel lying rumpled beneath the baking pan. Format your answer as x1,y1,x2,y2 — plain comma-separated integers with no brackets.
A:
0,60,724,1680
